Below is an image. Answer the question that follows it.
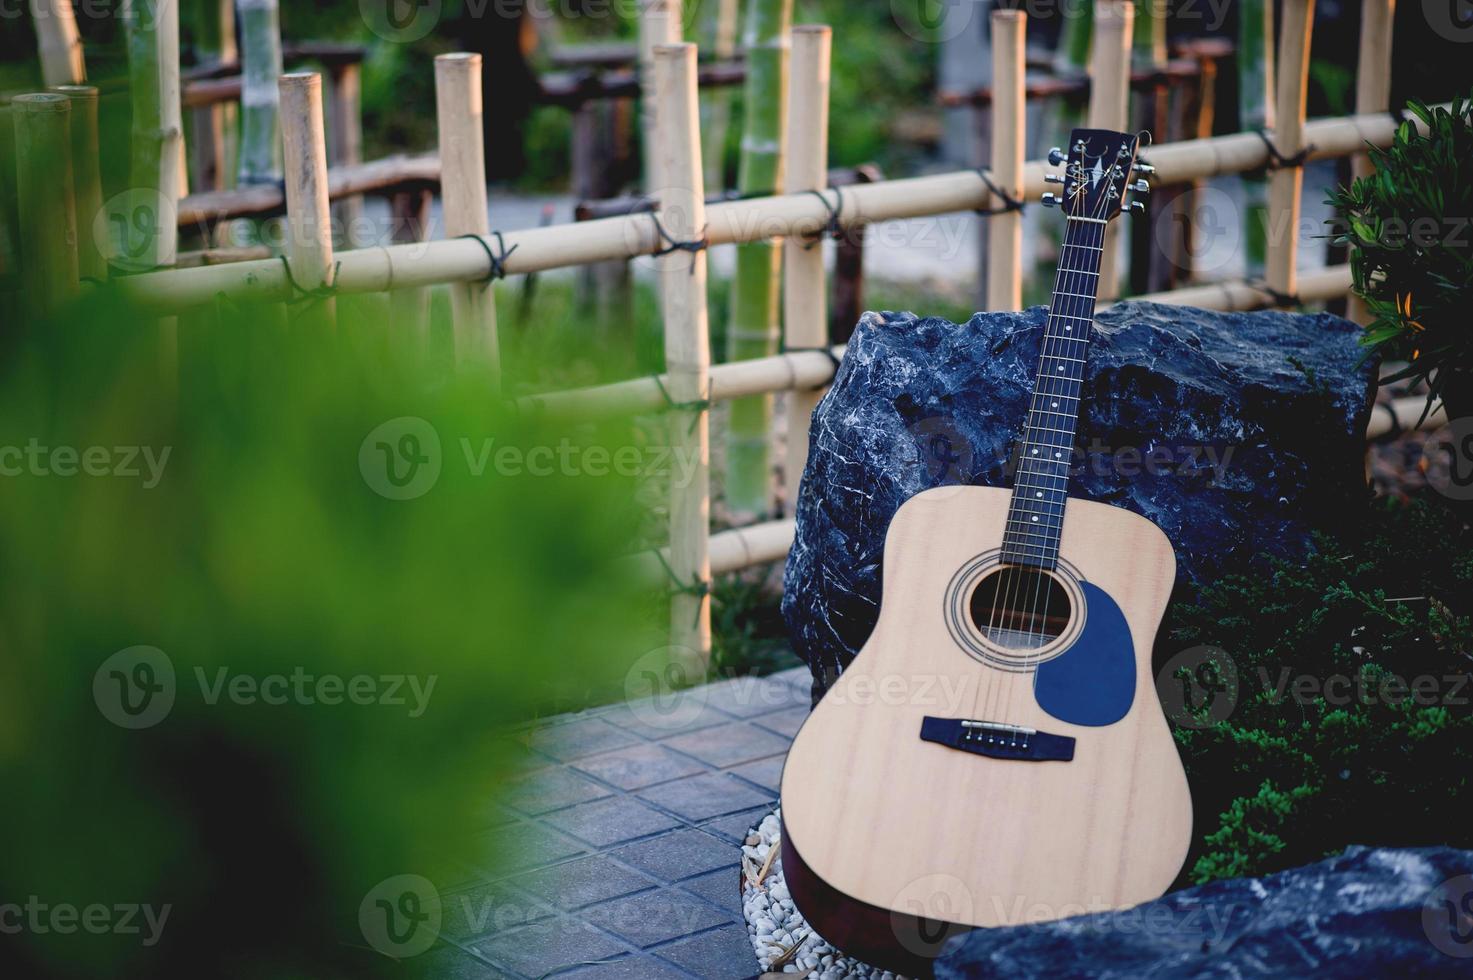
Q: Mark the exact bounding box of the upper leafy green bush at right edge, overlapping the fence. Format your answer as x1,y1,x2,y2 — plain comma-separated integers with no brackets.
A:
1329,97,1473,417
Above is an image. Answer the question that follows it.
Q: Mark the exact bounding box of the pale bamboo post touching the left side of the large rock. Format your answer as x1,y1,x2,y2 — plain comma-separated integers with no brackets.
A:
782,24,834,498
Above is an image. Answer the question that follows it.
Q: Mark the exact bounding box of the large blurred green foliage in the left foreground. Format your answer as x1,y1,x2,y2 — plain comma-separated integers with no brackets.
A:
0,290,664,977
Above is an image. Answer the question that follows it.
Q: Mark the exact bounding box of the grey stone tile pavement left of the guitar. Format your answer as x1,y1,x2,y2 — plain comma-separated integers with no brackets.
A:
412,668,809,980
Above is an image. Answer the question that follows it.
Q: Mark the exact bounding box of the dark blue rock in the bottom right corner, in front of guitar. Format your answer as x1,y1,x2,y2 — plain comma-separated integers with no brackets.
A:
935,847,1473,980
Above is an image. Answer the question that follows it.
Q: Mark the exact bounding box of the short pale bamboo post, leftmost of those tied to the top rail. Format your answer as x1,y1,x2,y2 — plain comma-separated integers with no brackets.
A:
278,72,337,327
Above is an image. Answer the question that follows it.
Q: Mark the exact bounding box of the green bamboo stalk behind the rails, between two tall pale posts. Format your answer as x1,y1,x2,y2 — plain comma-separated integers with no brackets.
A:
726,0,792,516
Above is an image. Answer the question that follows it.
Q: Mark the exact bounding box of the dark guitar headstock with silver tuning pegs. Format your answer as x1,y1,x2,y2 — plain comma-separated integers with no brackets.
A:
1043,130,1155,223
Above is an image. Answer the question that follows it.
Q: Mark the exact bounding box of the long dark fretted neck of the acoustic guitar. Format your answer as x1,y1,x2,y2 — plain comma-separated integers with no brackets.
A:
1003,217,1106,569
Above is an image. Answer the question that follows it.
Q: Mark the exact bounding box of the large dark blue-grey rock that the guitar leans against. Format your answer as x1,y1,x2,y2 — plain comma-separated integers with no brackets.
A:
782,302,1374,684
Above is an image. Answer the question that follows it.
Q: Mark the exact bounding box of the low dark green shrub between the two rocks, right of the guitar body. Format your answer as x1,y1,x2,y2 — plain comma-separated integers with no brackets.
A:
1162,501,1473,883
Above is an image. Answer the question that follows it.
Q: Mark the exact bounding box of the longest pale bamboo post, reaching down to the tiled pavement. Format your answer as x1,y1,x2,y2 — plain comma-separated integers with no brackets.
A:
653,44,711,669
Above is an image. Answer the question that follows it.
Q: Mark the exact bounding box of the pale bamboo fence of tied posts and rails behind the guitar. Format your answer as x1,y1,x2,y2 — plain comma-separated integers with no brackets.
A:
13,0,1421,663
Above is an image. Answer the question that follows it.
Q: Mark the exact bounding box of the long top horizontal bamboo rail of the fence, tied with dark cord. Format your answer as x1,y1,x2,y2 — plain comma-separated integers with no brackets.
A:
119,113,1426,312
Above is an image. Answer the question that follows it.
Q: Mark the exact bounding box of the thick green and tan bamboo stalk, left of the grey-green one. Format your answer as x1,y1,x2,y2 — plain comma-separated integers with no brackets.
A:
116,0,184,267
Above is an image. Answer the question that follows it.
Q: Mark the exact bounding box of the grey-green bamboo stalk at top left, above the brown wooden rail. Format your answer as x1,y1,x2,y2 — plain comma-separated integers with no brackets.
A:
239,0,283,186
